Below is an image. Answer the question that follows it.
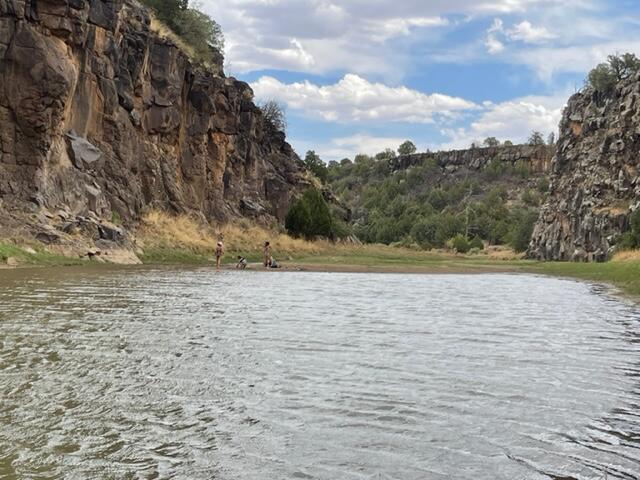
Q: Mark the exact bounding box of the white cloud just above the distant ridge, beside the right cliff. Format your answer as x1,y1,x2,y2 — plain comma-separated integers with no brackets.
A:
440,91,569,149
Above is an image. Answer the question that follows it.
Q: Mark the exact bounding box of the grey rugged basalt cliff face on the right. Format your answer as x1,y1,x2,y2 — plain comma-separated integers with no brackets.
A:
529,75,640,261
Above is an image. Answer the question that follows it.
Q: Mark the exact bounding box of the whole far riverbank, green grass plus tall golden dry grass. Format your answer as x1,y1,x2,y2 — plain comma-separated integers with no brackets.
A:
0,212,640,299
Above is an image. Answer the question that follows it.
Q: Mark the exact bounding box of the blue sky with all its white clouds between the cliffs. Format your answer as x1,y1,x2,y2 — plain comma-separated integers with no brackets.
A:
200,0,640,161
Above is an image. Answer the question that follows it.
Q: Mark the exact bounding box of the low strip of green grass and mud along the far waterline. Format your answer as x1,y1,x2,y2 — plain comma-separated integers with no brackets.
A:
5,242,640,304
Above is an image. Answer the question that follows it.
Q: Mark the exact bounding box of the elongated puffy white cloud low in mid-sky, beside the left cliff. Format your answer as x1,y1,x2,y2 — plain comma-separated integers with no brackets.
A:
251,74,477,123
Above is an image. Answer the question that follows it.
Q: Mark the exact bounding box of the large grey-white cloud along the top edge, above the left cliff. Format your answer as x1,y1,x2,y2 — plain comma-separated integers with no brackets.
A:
202,0,556,73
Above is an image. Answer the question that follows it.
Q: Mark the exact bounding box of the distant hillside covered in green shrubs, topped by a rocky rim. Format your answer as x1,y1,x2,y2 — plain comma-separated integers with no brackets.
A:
328,145,554,251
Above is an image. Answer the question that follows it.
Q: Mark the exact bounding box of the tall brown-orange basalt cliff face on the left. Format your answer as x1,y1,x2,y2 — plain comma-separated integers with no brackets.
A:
0,0,304,232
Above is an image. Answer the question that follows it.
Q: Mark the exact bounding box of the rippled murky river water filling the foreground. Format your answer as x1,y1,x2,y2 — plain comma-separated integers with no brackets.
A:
0,268,640,480
